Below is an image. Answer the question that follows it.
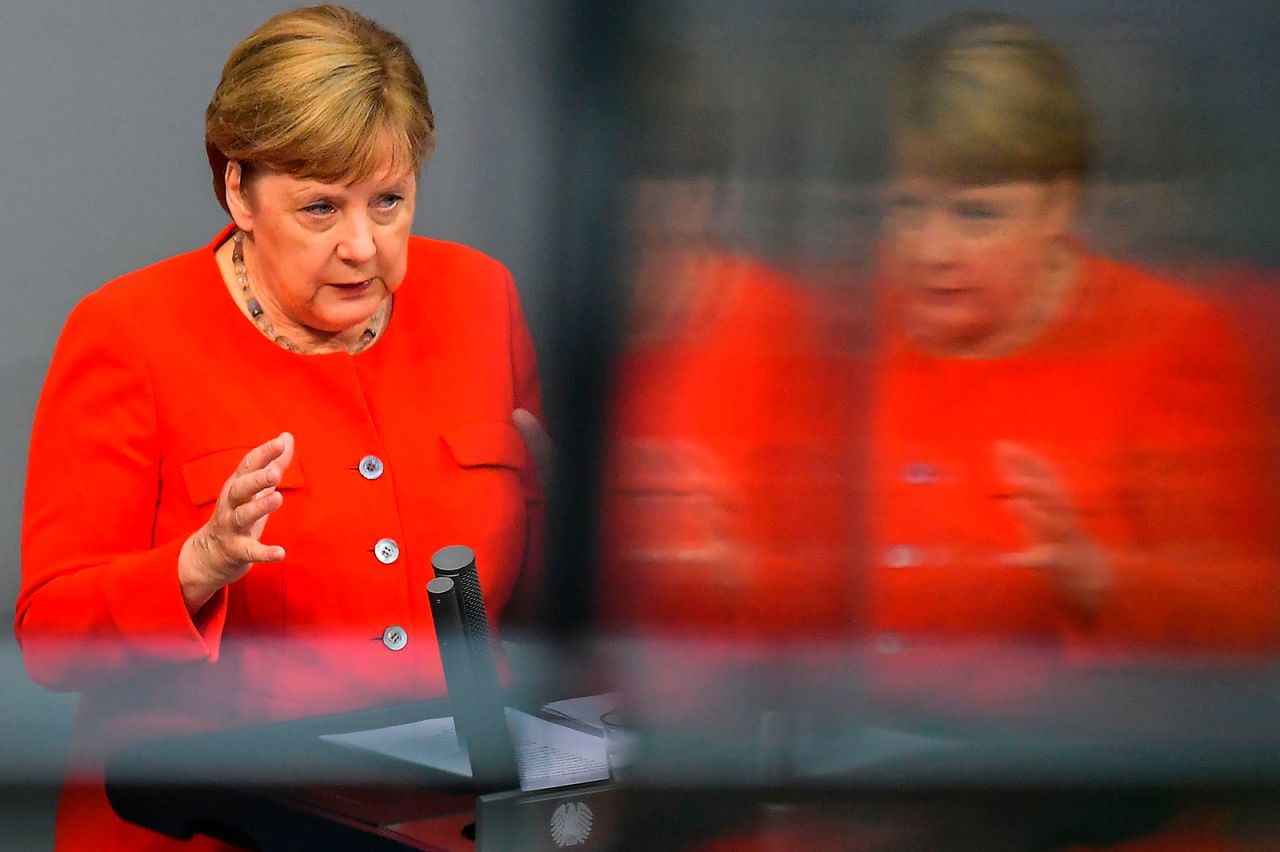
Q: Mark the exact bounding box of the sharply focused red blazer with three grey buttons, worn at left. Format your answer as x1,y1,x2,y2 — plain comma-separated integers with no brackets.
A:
15,230,540,849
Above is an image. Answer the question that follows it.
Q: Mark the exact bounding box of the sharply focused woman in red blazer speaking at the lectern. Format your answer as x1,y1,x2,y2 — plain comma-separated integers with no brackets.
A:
17,6,540,849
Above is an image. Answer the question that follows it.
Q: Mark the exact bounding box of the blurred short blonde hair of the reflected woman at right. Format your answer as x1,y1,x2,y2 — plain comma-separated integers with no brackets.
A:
890,14,1093,185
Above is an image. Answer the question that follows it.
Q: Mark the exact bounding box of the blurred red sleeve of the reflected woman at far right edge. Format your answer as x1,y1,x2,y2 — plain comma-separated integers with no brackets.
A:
1059,311,1280,650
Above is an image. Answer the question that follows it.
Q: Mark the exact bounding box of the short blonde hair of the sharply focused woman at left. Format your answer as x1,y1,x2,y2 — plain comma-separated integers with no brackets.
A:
205,5,435,209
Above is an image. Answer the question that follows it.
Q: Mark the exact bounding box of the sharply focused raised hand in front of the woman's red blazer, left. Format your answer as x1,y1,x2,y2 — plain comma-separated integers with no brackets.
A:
178,432,293,613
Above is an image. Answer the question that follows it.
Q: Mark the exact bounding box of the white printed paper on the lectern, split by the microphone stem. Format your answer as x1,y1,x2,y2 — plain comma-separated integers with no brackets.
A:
320,707,609,791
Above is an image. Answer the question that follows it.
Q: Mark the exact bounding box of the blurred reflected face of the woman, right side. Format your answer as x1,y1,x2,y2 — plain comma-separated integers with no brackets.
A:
886,175,1075,356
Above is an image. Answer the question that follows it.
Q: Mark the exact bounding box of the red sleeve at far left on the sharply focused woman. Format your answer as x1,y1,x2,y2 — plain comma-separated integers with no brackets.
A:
14,296,227,691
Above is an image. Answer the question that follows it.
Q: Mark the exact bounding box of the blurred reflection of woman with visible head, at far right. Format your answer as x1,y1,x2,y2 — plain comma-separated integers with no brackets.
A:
868,15,1276,651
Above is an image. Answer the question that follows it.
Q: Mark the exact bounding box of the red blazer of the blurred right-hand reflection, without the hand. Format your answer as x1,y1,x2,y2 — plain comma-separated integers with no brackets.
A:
869,257,1280,649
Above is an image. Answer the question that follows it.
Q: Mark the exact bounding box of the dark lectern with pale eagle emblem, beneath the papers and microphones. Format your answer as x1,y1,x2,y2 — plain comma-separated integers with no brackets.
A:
106,701,614,852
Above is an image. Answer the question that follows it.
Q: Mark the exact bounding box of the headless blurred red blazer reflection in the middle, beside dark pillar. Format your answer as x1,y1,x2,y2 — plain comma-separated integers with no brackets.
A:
600,253,867,640
